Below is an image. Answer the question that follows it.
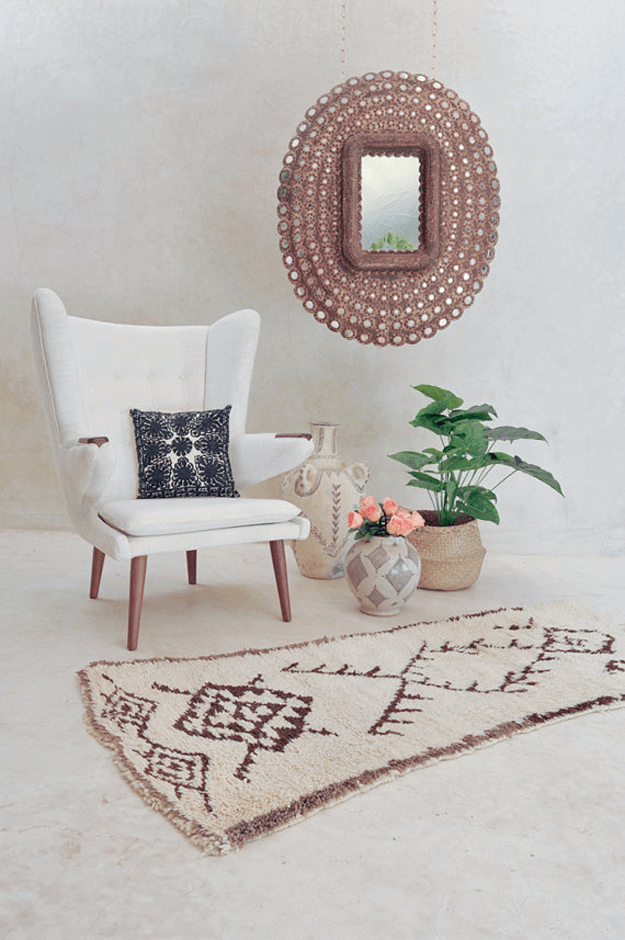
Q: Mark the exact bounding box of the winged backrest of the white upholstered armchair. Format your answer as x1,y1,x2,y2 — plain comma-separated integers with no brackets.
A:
31,288,260,500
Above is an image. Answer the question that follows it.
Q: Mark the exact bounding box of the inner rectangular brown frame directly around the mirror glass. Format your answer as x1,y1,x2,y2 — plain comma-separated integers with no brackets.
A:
342,131,441,273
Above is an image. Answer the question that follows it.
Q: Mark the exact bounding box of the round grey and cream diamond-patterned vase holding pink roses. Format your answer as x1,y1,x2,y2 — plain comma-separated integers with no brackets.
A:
345,535,421,617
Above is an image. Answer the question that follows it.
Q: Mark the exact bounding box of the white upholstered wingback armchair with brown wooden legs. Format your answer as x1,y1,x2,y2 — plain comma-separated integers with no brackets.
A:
30,288,312,649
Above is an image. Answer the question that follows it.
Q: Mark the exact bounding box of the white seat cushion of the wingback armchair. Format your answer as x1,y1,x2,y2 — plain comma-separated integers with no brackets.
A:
98,496,300,536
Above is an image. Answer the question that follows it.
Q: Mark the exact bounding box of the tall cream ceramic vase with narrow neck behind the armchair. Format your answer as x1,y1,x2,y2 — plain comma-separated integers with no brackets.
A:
282,422,369,579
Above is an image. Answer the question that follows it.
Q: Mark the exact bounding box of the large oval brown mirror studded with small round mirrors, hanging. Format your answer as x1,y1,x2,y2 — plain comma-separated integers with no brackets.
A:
278,72,500,346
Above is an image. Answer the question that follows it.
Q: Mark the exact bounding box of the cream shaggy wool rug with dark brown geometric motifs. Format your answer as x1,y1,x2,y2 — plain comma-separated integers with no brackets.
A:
78,605,625,855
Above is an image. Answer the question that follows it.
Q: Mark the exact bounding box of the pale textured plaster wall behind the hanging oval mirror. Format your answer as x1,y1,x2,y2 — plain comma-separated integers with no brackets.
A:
0,0,625,554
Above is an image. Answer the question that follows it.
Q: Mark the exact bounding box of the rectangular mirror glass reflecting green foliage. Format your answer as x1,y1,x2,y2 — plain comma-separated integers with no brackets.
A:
361,154,421,251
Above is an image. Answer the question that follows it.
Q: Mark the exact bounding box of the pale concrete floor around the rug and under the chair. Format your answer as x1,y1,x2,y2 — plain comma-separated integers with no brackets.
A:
0,532,625,940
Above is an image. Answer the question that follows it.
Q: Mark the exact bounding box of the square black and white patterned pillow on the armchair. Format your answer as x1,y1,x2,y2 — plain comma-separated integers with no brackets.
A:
130,405,239,499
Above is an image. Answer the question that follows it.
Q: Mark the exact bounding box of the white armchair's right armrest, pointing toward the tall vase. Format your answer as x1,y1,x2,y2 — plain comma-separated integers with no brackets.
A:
230,434,313,490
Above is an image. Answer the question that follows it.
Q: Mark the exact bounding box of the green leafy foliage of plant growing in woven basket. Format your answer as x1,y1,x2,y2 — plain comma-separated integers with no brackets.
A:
389,385,563,526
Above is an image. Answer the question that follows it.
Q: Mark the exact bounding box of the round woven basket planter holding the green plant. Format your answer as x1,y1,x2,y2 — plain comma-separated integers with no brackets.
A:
408,509,486,591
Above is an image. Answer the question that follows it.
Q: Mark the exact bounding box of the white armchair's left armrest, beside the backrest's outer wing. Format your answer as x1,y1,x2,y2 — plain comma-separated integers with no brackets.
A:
60,437,117,512
